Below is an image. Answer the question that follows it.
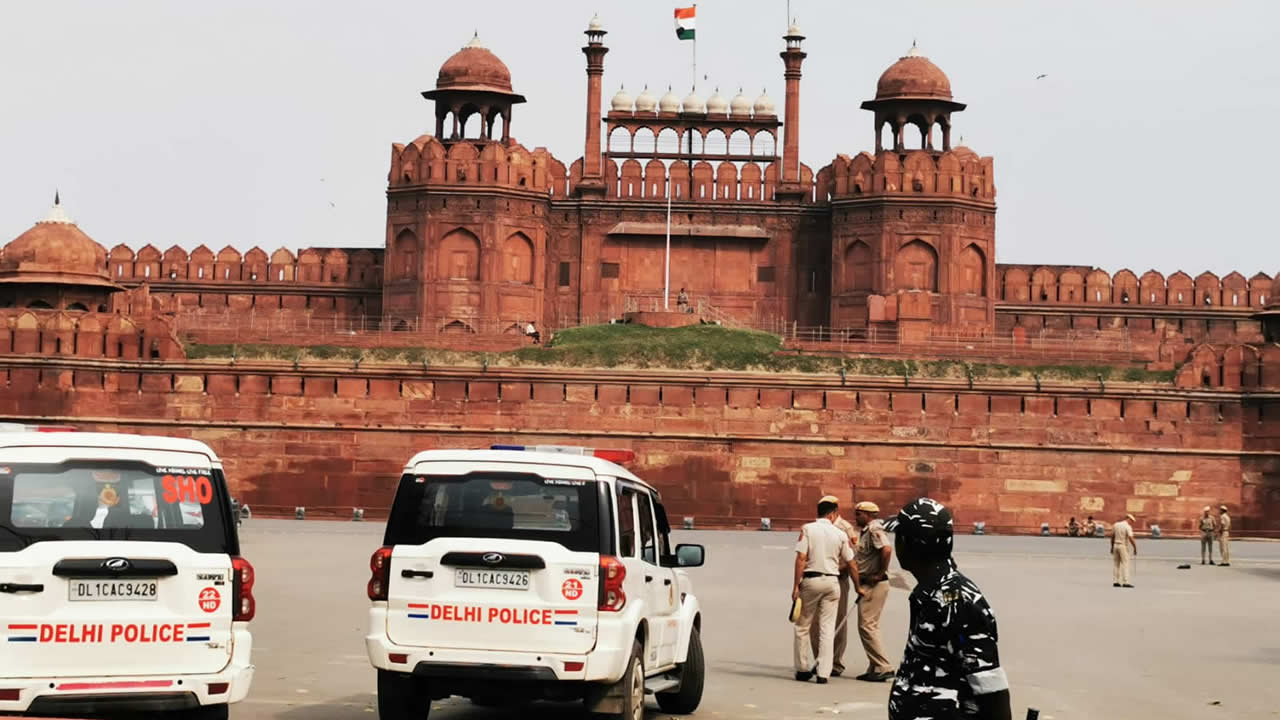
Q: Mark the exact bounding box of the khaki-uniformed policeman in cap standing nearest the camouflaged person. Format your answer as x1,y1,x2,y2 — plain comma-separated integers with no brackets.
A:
854,500,893,683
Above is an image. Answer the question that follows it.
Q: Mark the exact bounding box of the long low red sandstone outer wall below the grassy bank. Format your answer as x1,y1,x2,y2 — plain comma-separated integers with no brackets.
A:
0,359,1280,534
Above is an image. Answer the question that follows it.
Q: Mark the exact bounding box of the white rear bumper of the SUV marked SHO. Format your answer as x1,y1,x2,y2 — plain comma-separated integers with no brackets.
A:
0,630,253,715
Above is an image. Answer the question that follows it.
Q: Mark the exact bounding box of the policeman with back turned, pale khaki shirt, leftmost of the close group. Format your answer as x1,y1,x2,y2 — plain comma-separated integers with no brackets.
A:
791,497,856,684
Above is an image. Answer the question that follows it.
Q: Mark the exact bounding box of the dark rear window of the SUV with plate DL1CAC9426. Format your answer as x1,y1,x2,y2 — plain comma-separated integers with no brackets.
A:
385,473,600,552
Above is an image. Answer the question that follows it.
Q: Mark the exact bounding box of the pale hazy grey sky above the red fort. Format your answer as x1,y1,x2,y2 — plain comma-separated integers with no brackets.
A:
0,0,1280,275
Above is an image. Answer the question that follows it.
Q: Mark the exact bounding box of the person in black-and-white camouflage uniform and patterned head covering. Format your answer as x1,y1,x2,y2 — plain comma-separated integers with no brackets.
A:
887,497,1012,720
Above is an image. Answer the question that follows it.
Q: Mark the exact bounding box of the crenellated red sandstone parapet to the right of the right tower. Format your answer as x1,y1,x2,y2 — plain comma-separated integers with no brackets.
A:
997,264,1280,310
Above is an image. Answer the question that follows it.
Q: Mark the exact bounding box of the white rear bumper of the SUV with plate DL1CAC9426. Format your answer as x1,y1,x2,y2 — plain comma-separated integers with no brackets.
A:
365,606,631,681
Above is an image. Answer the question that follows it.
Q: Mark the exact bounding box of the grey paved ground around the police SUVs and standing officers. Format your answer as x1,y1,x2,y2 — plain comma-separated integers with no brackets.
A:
232,520,1280,720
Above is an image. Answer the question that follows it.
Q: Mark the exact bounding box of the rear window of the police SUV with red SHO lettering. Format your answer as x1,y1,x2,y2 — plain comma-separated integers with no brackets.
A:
0,462,239,555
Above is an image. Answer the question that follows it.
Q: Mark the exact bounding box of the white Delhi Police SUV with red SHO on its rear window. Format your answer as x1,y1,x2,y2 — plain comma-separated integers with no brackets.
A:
0,425,255,720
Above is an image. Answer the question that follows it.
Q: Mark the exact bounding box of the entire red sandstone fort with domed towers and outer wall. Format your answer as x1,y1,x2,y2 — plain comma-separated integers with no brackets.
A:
0,20,1280,536
